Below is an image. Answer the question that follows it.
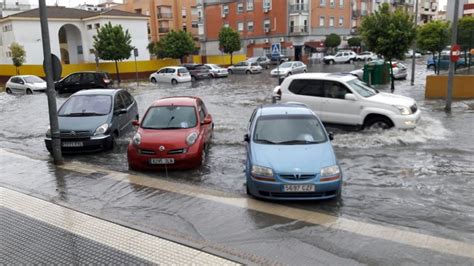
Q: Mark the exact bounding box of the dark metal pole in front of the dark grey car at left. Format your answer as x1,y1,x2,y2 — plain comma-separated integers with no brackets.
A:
39,0,63,164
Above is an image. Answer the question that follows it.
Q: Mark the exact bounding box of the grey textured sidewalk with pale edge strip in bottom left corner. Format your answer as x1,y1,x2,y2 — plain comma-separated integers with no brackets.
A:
0,187,237,265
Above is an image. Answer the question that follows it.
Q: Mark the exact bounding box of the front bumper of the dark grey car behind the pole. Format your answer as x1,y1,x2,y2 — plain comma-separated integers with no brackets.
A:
44,135,113,153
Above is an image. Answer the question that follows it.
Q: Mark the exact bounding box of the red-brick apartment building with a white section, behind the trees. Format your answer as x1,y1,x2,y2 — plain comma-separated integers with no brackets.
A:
202,0,352,59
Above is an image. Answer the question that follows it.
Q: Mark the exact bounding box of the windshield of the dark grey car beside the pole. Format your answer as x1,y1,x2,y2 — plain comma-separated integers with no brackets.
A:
58,95,112,116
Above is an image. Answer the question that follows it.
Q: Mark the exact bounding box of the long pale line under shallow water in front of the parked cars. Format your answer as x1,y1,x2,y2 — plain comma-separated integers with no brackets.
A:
0,149,474,259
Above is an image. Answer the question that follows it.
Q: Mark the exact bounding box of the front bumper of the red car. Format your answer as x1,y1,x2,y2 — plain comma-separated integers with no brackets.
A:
127,144,202,170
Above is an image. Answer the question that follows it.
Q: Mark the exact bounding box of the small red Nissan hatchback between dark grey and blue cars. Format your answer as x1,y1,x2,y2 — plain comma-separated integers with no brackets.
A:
127,97,214,170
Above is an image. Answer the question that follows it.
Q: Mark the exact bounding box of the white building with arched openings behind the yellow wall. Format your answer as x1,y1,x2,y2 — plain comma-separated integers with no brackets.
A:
0,7,150,65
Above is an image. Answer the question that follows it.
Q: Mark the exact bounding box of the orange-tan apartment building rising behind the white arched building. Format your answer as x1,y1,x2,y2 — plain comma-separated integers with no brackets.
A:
113,0,199,43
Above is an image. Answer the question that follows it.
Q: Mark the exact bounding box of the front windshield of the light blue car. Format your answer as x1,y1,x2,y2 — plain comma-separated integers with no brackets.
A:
254,115,327,145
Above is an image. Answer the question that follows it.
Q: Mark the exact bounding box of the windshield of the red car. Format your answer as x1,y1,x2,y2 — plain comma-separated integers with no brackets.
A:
141,105,197,129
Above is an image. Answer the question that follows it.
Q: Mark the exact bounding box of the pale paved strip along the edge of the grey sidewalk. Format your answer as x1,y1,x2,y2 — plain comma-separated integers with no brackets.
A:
0,187,239,265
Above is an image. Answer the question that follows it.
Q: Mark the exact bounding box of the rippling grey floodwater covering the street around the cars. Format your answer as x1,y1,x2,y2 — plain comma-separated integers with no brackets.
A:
0,59,474,264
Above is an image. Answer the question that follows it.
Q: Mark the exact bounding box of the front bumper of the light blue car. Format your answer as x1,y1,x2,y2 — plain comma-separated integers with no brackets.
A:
247,176,342,200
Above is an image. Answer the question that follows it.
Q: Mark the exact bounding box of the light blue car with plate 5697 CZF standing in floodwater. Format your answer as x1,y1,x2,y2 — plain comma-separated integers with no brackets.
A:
244,103,342,200
